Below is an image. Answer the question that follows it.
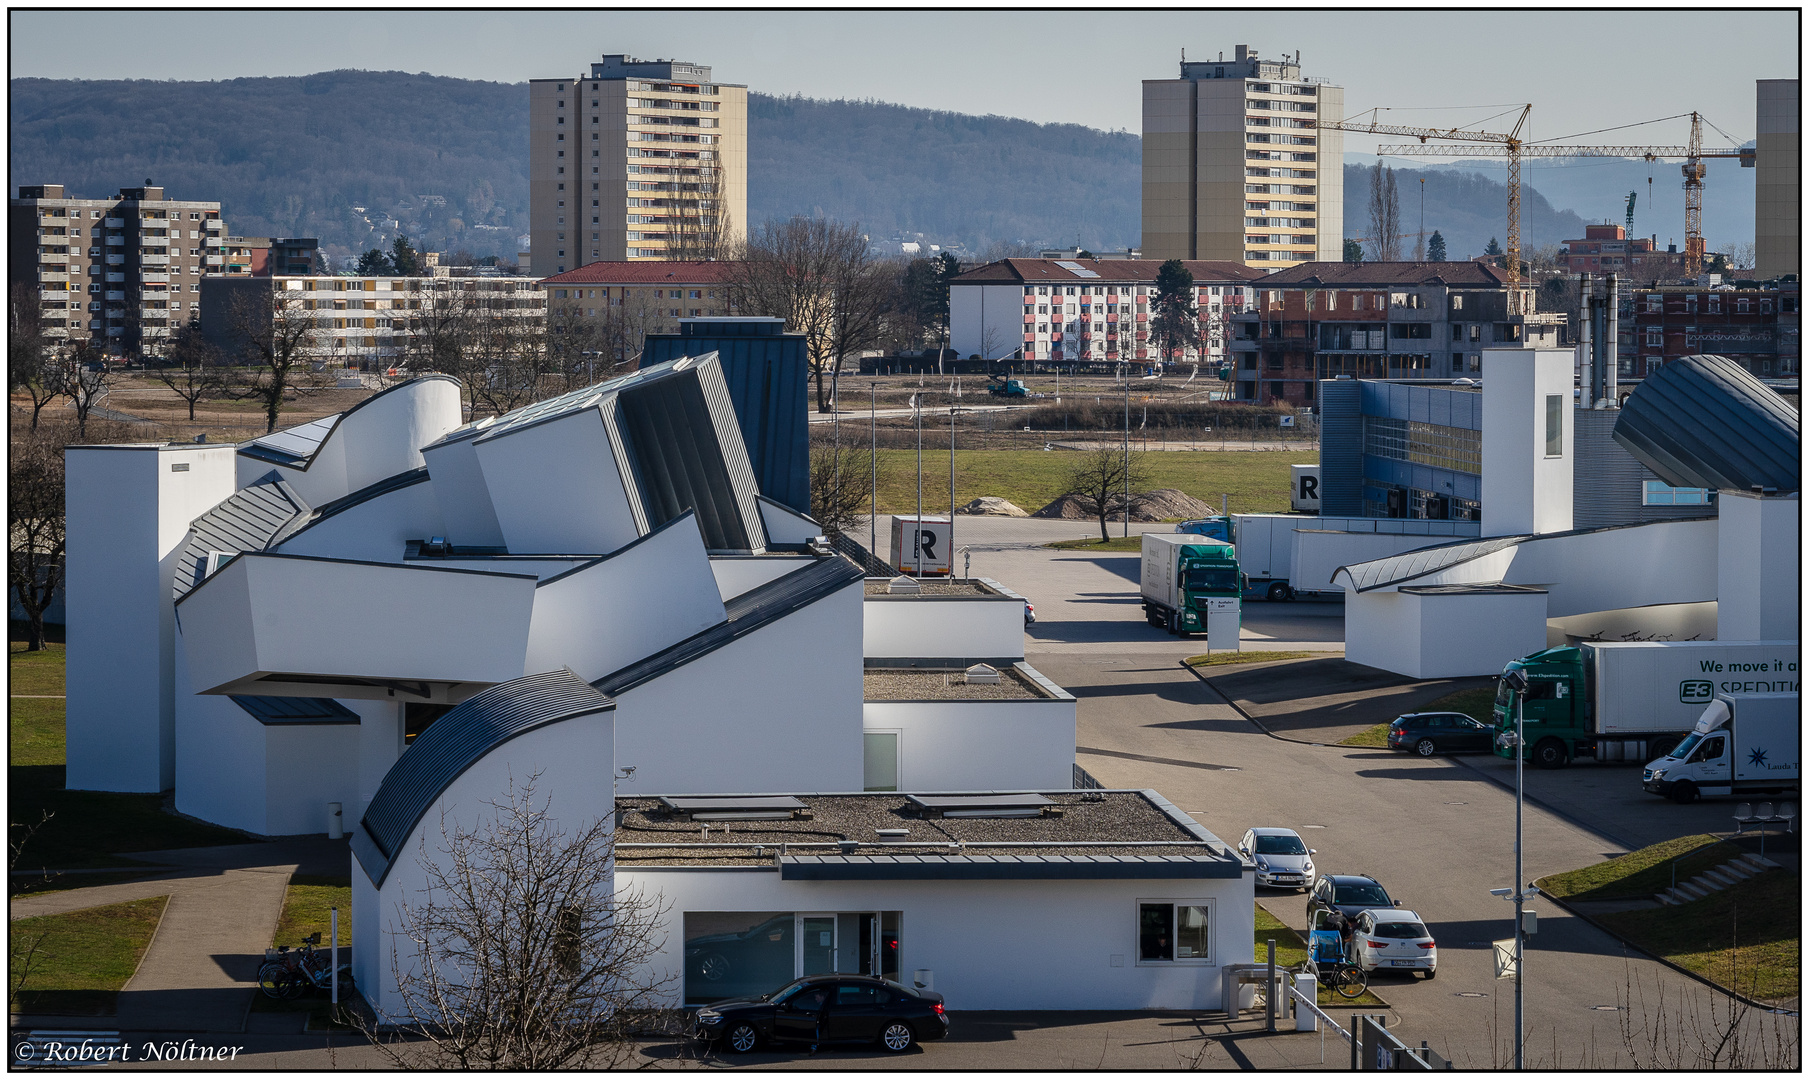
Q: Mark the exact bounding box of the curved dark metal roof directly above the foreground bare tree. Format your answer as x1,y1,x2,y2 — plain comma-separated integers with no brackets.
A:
351,668,615,888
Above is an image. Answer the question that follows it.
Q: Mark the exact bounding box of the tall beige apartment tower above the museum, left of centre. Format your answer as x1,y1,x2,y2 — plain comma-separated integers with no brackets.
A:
528,54,747,277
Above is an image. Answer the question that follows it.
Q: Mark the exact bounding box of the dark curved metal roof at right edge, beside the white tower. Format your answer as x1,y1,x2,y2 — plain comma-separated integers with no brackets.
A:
1614,356,1802,492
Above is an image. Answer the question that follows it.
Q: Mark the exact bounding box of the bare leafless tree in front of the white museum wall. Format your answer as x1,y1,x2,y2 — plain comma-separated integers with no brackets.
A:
371,774,671,1071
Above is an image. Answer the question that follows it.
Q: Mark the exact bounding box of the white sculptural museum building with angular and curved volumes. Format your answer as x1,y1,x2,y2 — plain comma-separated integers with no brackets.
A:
67,355,1254,1013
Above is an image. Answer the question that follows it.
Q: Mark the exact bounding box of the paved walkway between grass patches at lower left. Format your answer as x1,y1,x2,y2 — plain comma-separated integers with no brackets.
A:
11,838,349,1033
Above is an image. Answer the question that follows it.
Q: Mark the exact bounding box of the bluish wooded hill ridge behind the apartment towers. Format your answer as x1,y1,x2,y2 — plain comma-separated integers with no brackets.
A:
9,71,1657,259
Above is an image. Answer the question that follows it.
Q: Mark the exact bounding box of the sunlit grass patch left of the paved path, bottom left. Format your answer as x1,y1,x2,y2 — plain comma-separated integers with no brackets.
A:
11,895,170,1017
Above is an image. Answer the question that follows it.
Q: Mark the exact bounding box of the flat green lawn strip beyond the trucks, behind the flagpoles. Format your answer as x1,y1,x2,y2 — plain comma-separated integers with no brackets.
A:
879,446,1319,513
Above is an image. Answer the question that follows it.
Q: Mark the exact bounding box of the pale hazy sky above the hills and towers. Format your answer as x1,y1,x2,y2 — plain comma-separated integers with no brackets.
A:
9,5,1800,152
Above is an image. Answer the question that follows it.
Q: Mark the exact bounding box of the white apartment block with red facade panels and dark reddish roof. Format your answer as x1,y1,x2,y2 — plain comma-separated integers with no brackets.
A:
948,259,1263,364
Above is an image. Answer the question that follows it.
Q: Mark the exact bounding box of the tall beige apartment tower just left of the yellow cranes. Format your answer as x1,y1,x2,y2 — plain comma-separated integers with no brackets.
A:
1143,45,1344,270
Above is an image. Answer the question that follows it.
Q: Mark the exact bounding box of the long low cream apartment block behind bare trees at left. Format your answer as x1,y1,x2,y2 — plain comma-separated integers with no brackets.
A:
201,268,546,371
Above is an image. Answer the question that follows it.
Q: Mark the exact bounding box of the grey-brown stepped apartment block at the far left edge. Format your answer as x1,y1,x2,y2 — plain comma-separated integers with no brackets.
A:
7,185,226,356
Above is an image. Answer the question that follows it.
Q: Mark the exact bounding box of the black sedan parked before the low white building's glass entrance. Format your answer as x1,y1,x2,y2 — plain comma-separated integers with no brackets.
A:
696,975,948,1053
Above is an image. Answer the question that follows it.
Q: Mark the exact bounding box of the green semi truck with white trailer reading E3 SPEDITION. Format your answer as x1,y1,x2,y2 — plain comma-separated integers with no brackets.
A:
1494,640,1798,769
